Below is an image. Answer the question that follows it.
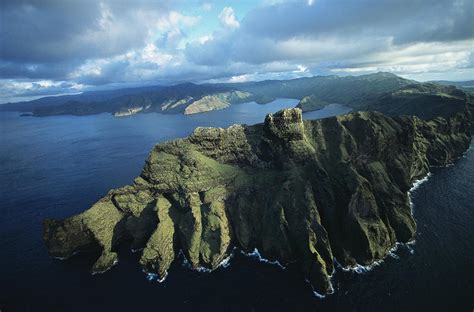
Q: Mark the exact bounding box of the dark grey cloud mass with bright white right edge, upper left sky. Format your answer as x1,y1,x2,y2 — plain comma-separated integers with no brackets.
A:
0,0,200,85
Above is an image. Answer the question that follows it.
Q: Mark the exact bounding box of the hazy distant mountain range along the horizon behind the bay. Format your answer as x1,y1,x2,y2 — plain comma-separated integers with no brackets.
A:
0,73,474,125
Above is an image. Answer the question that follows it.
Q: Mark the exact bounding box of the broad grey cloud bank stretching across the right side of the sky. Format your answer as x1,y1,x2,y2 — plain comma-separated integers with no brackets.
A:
187,0,474,80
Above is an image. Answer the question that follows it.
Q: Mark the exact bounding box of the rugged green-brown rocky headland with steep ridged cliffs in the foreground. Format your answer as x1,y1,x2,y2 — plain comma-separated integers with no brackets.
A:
44,109,471,294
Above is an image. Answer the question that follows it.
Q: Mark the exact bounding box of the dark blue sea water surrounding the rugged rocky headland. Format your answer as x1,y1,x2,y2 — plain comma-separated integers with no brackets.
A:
0,99,474,312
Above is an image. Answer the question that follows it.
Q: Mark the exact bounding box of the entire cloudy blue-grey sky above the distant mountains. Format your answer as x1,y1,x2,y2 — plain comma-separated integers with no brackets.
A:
0,0,474,103
